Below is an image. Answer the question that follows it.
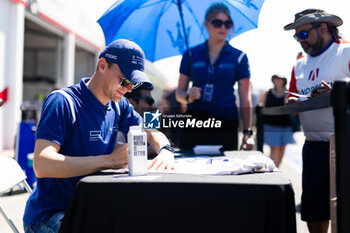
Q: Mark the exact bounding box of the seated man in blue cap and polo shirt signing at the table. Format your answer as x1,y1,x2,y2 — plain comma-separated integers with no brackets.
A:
23,39,174,232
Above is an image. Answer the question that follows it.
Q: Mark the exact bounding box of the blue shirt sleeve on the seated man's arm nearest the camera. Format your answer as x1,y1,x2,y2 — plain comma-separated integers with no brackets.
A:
36,93,73,146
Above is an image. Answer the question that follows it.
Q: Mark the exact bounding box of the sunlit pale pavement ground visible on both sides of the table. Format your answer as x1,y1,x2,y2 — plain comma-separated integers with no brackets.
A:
0,132,330,233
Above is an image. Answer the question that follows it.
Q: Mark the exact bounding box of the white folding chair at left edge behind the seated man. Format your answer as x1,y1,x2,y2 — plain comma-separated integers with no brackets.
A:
0,156,32,233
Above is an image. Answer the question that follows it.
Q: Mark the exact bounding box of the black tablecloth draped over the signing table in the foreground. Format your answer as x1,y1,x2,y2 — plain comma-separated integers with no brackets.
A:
60,152,296,233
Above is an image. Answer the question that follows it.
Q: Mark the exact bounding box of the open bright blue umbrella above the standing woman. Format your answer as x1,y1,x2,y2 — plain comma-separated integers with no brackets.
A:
98,0,264,62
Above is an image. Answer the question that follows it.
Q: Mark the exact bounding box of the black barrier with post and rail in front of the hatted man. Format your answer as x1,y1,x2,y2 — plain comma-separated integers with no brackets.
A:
255,81,350,233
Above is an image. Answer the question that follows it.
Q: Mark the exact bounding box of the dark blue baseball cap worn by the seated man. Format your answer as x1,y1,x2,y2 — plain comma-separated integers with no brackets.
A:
99,39,153,87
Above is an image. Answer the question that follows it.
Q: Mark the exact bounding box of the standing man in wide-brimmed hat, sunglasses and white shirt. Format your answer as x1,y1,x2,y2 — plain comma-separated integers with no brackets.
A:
284,9,350,233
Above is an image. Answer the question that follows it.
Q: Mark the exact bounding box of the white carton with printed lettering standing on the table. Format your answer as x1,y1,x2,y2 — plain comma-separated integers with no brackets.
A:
128,125,147,176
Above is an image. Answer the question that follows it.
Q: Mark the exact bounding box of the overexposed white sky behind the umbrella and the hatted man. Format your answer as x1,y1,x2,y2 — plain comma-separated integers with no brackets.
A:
154,0,350,89
